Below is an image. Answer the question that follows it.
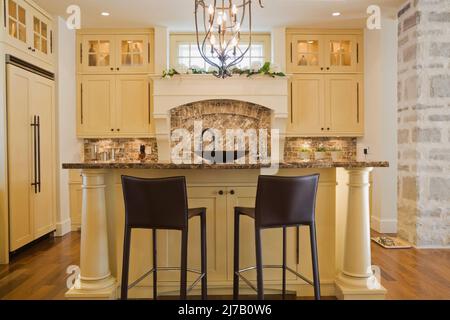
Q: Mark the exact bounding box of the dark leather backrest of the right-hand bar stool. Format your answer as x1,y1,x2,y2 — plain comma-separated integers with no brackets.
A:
255,174,319,228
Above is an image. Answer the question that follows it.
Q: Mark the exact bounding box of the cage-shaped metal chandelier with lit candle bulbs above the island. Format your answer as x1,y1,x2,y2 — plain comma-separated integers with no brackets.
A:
195,0,264,78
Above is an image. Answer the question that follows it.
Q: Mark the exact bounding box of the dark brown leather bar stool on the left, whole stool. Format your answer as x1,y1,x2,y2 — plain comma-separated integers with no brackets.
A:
121,176,207,300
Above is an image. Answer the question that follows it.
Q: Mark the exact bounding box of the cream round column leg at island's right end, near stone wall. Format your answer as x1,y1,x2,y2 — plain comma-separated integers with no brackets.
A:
336,168,386,299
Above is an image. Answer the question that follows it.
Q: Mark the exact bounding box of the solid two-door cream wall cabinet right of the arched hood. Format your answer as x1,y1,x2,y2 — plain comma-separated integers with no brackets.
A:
288,74,364,137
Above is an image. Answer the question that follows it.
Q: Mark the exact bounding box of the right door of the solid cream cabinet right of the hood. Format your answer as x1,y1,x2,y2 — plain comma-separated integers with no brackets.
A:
325,74,364,136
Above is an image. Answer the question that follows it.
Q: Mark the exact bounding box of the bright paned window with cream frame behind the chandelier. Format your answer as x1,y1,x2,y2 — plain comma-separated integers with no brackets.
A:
170,34,271,70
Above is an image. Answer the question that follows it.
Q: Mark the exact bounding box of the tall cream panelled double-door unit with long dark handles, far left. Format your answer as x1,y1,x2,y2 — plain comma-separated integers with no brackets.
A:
7,61,56,251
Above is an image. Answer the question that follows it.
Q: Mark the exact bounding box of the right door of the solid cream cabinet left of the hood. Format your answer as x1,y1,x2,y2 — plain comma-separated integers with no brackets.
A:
115,75,152,137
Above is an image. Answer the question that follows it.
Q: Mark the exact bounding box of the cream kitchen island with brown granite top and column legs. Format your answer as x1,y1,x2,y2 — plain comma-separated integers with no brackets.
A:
63,161,389,299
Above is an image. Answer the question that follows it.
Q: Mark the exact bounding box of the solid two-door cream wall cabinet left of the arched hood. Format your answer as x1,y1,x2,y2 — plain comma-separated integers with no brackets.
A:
77,74,153,138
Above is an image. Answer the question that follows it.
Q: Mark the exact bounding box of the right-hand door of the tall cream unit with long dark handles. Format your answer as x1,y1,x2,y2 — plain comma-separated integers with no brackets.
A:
30,75,56,239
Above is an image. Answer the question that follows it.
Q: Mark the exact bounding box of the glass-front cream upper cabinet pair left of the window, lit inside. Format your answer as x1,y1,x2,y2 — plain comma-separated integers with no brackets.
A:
77,29,154,74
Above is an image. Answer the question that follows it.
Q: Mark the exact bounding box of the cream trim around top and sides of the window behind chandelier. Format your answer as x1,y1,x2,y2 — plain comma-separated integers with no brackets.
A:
169,33,272,68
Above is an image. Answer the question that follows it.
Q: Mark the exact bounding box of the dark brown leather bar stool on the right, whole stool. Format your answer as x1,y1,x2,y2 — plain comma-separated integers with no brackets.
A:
233,174,320,300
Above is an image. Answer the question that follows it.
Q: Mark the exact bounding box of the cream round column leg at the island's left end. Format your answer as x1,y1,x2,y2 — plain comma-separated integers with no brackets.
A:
66,170,117,299
